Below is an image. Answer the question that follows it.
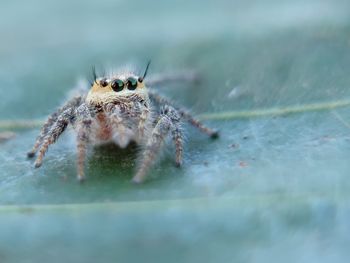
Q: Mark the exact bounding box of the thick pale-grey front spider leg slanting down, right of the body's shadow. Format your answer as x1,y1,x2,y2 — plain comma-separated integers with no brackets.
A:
132,106,182,183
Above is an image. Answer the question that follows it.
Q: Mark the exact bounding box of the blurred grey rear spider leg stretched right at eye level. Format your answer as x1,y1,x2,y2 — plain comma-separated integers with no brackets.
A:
145,71,199,87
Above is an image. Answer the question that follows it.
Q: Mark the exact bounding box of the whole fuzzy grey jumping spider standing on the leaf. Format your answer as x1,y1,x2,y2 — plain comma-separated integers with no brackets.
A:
28,63,218,183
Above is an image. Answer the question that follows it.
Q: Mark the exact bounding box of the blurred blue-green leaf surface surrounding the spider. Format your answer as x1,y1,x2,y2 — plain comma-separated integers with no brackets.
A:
0,0,350,262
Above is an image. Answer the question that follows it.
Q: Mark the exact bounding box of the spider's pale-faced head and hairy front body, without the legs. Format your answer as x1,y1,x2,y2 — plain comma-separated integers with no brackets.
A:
85,74,152,148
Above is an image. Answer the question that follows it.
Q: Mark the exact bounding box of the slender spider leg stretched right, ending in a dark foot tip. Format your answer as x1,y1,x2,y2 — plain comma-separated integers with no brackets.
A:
149,91,219,138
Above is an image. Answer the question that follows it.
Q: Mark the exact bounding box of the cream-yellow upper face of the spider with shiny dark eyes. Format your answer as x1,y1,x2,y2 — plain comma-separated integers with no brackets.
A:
87,74,147,103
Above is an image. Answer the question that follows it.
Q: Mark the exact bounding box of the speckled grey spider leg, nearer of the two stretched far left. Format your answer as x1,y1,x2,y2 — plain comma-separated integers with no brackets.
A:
35,108,74,168
